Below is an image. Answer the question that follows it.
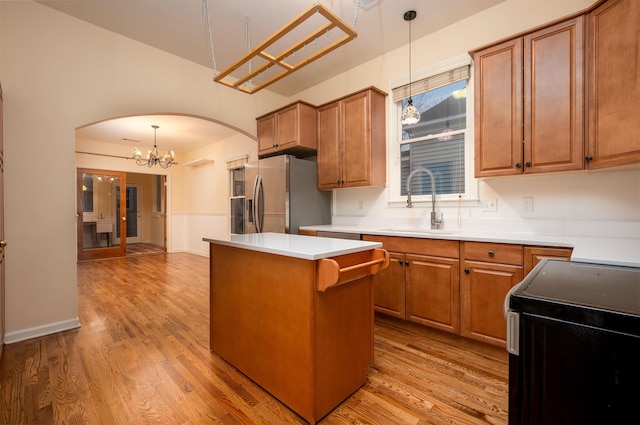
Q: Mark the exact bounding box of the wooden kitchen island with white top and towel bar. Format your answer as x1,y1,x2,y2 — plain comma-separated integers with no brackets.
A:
203,233,389,424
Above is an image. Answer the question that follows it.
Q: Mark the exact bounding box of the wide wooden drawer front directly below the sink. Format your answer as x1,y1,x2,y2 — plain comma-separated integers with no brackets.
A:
362,235,460,258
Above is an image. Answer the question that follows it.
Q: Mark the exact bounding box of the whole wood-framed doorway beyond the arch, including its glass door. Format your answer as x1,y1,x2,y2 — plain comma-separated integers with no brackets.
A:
77,168,167,261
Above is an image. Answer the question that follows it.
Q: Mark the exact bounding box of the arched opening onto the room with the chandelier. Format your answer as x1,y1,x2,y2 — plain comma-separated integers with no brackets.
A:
76,114,257,259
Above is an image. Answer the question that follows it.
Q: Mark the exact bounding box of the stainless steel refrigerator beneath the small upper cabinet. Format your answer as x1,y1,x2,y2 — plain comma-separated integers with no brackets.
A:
244,155,331,234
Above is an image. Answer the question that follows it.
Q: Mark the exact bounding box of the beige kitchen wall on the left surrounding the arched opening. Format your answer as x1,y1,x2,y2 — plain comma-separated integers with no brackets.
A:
0,1,285,342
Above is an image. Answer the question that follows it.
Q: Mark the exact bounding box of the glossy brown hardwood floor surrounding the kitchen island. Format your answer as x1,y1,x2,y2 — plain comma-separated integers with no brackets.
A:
0,253,508,425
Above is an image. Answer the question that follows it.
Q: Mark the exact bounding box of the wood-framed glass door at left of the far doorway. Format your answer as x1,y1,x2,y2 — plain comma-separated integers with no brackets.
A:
77,168,127,260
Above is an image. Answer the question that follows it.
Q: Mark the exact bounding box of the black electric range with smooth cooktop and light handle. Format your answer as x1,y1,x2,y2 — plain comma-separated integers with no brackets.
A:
505,259,640,425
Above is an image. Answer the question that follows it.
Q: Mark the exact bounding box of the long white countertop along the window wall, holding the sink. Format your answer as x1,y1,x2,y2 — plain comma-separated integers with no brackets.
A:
301,224,640,267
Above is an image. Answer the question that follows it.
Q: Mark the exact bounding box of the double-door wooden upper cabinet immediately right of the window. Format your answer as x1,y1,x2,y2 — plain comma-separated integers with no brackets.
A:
473,15,585,177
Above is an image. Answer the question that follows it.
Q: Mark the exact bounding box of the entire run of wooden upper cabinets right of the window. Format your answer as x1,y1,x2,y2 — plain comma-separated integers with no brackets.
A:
470,0,640,177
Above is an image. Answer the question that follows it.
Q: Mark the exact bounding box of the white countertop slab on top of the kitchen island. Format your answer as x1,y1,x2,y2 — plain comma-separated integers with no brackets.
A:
202,233,382,260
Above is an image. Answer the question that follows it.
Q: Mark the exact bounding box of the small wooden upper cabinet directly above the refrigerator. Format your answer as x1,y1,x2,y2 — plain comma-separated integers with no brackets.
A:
256,101,317,158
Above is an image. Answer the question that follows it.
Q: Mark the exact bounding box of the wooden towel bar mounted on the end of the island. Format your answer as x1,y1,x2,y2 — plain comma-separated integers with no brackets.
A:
317,245,389,292
